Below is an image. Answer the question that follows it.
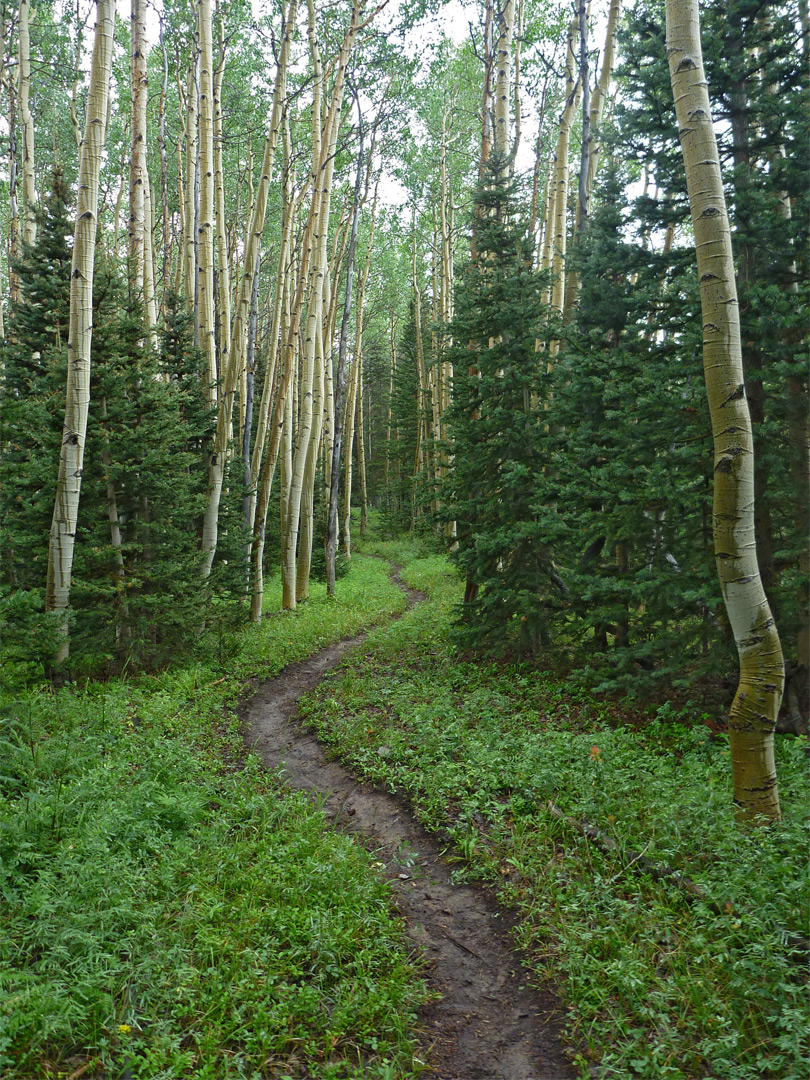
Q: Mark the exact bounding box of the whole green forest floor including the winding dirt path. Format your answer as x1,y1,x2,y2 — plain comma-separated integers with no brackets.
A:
0,536,810,1080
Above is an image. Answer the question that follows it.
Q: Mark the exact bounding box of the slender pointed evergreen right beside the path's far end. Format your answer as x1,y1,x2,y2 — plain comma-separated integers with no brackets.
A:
442,154,565,651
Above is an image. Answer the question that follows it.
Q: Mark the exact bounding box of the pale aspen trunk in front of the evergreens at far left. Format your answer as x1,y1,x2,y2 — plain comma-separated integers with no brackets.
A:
45,0,114,671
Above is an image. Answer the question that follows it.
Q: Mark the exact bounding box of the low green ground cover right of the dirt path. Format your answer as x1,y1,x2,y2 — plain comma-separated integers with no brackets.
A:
305,544,810,1080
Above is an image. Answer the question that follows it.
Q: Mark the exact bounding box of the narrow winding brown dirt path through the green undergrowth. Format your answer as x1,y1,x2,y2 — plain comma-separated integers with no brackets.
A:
243,585,576,1080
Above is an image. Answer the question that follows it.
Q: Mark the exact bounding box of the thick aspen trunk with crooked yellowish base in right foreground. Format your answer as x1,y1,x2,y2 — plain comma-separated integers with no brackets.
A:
666,0,784,822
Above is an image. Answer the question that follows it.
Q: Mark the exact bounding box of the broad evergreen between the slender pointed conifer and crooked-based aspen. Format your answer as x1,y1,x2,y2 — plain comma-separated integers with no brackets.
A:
543,163,731,693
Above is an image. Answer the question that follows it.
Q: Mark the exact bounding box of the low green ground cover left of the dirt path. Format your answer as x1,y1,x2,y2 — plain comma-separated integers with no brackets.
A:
0,557,424,1080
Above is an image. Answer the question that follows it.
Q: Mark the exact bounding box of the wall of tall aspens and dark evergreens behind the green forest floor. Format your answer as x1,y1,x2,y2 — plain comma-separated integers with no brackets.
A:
0,0,809,730
